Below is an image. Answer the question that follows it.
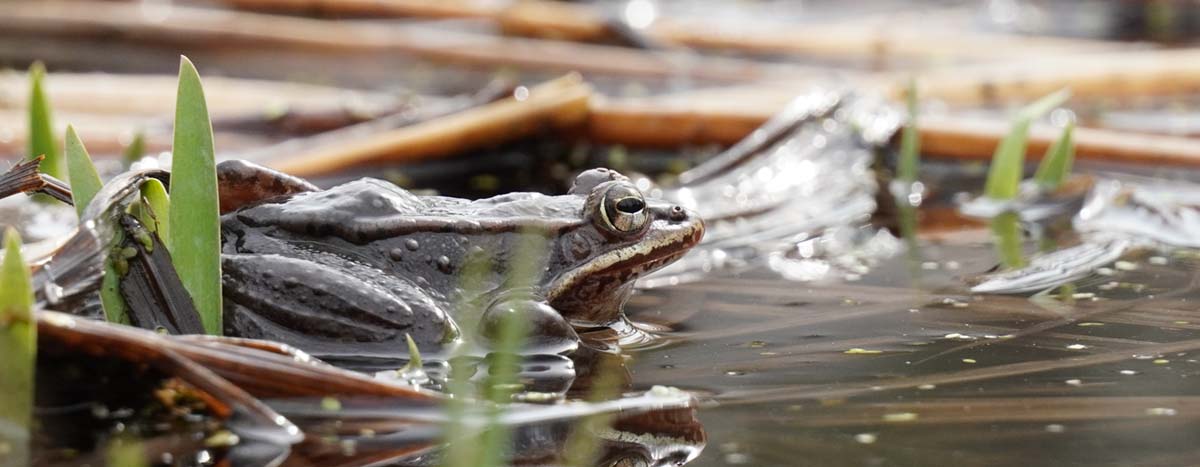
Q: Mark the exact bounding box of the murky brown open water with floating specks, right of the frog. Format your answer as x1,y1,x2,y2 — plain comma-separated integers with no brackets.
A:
631,235,1200,466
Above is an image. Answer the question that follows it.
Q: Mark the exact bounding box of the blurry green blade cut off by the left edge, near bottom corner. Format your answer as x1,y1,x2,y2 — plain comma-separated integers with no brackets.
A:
0,228,37,466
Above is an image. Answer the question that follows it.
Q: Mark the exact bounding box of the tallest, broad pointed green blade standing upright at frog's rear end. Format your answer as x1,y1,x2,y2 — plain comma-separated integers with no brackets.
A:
167,56,221,335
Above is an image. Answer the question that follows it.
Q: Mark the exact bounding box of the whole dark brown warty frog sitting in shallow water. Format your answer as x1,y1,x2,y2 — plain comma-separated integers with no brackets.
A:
221,162,704,354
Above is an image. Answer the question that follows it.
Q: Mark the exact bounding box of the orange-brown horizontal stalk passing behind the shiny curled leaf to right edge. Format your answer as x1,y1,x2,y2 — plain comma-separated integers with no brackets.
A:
589,91,1200,166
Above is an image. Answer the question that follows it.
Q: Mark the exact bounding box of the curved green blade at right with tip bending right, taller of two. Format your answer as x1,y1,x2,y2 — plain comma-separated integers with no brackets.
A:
984,90,1070,199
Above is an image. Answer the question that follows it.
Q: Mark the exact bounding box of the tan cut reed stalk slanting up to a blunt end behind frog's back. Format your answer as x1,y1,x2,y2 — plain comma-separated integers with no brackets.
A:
264,74,592,176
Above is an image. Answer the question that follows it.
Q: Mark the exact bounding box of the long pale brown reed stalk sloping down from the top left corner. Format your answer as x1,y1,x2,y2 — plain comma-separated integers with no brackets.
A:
0,1,828,82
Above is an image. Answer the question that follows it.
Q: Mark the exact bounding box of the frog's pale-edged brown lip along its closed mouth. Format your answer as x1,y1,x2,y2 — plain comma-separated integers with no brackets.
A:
547,222,704,300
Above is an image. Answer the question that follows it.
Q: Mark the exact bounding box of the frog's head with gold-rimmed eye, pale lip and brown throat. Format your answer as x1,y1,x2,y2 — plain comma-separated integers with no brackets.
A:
546,169,704,325
